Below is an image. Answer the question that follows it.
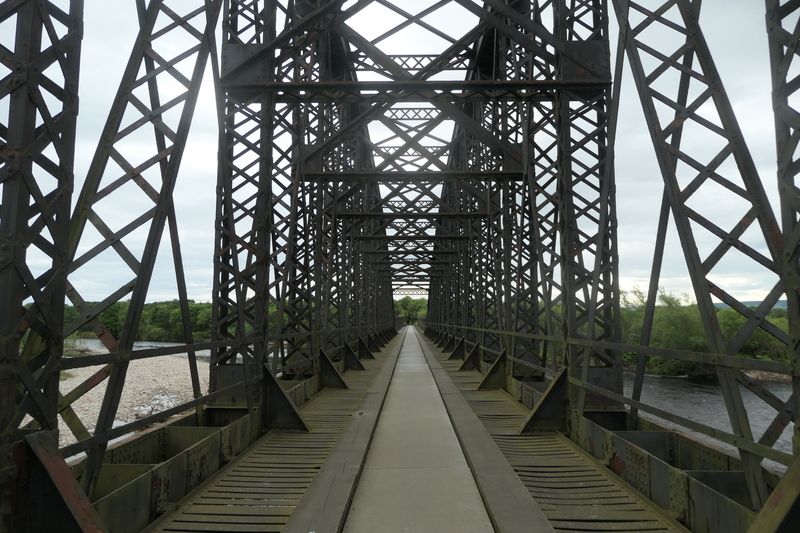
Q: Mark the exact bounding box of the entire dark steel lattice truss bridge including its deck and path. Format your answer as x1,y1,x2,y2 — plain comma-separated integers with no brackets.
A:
0,0,800,533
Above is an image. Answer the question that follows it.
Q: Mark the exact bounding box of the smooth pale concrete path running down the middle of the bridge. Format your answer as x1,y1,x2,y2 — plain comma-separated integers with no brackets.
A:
345,327,493,533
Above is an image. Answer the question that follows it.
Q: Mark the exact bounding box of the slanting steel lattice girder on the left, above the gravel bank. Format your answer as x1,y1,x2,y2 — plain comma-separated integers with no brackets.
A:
67,0,222,493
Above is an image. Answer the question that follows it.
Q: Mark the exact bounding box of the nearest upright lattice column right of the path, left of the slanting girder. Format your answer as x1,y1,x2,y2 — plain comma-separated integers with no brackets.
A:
553,2,622,412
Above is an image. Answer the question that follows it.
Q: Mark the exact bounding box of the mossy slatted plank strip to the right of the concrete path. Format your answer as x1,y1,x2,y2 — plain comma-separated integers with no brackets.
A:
419,335,687,532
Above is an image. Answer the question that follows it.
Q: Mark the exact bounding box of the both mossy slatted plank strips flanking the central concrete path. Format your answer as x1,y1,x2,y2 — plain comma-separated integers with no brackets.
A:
151,328,686,532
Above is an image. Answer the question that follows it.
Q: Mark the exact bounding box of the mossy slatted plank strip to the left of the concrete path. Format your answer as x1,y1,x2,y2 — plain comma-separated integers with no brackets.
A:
148,335,403,532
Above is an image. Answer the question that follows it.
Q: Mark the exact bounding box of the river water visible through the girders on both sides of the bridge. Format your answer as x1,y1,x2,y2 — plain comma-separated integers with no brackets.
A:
65,339,792,453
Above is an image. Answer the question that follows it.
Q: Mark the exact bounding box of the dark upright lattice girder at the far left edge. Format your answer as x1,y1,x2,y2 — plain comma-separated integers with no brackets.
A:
0,1,83,448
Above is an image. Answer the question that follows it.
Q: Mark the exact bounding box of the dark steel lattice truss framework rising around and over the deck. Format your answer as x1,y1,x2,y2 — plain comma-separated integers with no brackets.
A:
0,0,800,529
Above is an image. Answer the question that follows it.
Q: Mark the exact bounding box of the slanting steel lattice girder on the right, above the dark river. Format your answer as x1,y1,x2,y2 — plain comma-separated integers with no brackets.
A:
614,0,783,508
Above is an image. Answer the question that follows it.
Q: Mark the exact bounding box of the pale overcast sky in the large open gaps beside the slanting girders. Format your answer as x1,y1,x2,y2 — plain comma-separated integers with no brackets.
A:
61,0,777,301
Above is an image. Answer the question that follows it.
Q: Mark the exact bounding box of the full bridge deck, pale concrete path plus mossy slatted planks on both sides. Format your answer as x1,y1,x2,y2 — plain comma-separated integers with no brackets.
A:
153,328,685,532
